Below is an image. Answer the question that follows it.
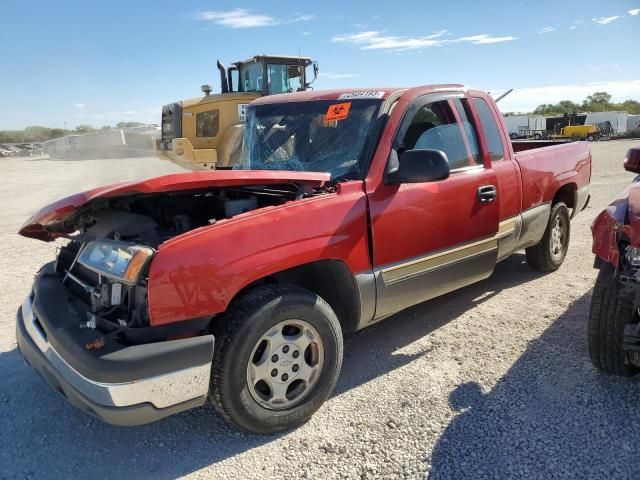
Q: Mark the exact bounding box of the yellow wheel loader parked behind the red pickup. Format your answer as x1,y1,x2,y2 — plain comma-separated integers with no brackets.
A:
156,55,318,170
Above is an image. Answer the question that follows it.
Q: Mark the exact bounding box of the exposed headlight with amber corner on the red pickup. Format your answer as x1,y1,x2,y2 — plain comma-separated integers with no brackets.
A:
78,240,154,285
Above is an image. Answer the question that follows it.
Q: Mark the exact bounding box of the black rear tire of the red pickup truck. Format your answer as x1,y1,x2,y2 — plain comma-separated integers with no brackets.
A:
525,202,571,272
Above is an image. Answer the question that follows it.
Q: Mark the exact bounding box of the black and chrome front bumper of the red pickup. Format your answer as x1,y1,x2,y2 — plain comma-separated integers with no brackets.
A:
16,275,214,426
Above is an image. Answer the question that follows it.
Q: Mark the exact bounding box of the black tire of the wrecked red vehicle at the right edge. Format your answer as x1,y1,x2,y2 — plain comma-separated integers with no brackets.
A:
588,263,640,377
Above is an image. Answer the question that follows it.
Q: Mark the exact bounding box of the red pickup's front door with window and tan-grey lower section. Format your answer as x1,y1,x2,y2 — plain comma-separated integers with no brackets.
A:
369,94,498,318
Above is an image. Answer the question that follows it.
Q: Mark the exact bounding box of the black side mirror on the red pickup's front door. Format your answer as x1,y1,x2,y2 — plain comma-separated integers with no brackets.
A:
385,150,451,185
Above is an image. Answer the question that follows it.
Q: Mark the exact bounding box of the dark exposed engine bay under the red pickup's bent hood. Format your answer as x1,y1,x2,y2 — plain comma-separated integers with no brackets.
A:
52,184,331,344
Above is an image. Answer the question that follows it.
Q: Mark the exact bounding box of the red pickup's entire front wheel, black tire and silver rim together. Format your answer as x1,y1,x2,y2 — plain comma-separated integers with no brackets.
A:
210,285,343,434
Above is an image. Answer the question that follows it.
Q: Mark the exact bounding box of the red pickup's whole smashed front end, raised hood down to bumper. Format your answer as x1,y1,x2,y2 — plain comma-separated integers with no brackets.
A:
16,172,328,425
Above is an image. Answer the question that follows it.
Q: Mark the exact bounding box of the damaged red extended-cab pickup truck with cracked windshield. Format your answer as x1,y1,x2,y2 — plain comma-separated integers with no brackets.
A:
17,85,591,433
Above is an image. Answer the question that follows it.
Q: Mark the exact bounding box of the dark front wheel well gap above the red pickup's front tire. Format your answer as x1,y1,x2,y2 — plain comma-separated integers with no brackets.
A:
236,260,360,332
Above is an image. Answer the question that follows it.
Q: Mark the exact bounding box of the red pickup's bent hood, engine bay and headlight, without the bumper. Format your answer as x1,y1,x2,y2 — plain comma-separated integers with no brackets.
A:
20,172,331,344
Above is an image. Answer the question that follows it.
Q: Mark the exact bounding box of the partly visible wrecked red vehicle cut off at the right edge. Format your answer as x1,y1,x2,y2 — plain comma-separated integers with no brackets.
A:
588,148,640,376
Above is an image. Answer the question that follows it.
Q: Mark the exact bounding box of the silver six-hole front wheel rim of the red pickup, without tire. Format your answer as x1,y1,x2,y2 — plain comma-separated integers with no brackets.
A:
247,319,324,410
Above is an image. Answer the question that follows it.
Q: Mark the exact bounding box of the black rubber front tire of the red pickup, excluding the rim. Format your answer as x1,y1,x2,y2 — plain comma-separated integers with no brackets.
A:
209,285,343,434
